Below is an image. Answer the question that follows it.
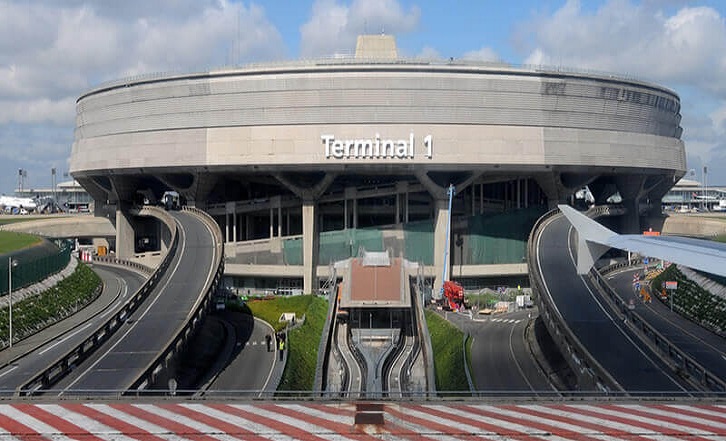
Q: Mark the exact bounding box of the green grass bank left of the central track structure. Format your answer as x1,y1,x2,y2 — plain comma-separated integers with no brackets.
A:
247,295,328,391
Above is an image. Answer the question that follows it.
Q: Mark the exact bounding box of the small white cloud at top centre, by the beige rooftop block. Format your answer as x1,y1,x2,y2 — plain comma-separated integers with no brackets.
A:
300,0,421,58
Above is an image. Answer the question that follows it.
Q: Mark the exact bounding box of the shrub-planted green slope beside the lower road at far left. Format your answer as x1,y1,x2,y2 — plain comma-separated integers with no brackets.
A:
0,263,101,347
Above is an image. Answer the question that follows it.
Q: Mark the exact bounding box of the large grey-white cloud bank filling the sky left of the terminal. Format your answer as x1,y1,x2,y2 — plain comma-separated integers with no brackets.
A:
0,0,286,190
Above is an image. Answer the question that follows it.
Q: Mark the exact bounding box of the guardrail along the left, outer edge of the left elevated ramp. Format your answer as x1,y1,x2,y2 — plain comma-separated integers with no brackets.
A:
15,207,179,396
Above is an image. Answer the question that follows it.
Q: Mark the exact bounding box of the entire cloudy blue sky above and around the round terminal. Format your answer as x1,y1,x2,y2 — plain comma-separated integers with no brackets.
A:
0,0,726,194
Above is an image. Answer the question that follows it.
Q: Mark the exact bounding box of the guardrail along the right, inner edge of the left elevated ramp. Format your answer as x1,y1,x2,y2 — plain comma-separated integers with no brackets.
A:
126,206,224,393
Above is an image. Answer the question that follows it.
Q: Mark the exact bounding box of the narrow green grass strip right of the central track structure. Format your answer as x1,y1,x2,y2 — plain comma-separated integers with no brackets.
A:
425,310,471,392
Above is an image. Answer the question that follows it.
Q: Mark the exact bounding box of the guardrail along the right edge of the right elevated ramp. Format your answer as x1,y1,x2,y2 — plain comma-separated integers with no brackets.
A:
589,260,726,392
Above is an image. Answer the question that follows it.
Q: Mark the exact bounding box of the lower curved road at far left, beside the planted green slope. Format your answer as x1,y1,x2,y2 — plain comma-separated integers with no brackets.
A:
0,265,146,393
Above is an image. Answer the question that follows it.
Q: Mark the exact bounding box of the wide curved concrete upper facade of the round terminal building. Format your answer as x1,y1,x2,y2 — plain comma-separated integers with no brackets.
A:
71,60,685,183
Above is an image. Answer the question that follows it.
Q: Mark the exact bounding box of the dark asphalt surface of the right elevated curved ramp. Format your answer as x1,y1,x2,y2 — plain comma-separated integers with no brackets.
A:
536,214,685,393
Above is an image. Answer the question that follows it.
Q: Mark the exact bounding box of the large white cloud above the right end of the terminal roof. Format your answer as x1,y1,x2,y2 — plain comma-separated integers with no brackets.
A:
520,0,726,96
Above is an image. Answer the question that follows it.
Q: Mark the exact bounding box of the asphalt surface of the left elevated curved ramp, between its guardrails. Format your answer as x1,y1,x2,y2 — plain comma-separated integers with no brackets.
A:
54,211,216,393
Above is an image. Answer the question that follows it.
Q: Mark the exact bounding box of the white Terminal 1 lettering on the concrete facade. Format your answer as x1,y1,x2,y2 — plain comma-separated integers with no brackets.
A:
320,132,434,159
